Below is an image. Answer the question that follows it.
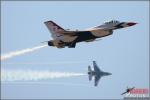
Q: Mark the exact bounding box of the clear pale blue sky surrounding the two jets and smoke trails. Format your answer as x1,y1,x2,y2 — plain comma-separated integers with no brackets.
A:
1,1,149,99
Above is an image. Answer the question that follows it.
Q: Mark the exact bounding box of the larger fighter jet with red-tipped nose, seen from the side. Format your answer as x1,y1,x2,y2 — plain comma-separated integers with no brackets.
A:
44,20,137,48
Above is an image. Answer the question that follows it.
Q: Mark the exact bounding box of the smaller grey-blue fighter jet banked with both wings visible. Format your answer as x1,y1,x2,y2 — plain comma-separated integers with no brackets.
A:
88,61,111,86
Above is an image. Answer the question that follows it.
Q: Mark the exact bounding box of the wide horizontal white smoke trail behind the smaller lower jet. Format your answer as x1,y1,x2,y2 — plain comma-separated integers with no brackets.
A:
1,70,86,82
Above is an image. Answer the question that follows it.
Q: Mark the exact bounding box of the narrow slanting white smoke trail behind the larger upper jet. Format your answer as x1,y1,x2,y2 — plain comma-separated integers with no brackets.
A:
1,45,48,60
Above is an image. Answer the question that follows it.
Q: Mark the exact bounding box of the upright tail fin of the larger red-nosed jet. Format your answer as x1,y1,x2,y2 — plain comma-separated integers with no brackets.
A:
44,21,65,38
